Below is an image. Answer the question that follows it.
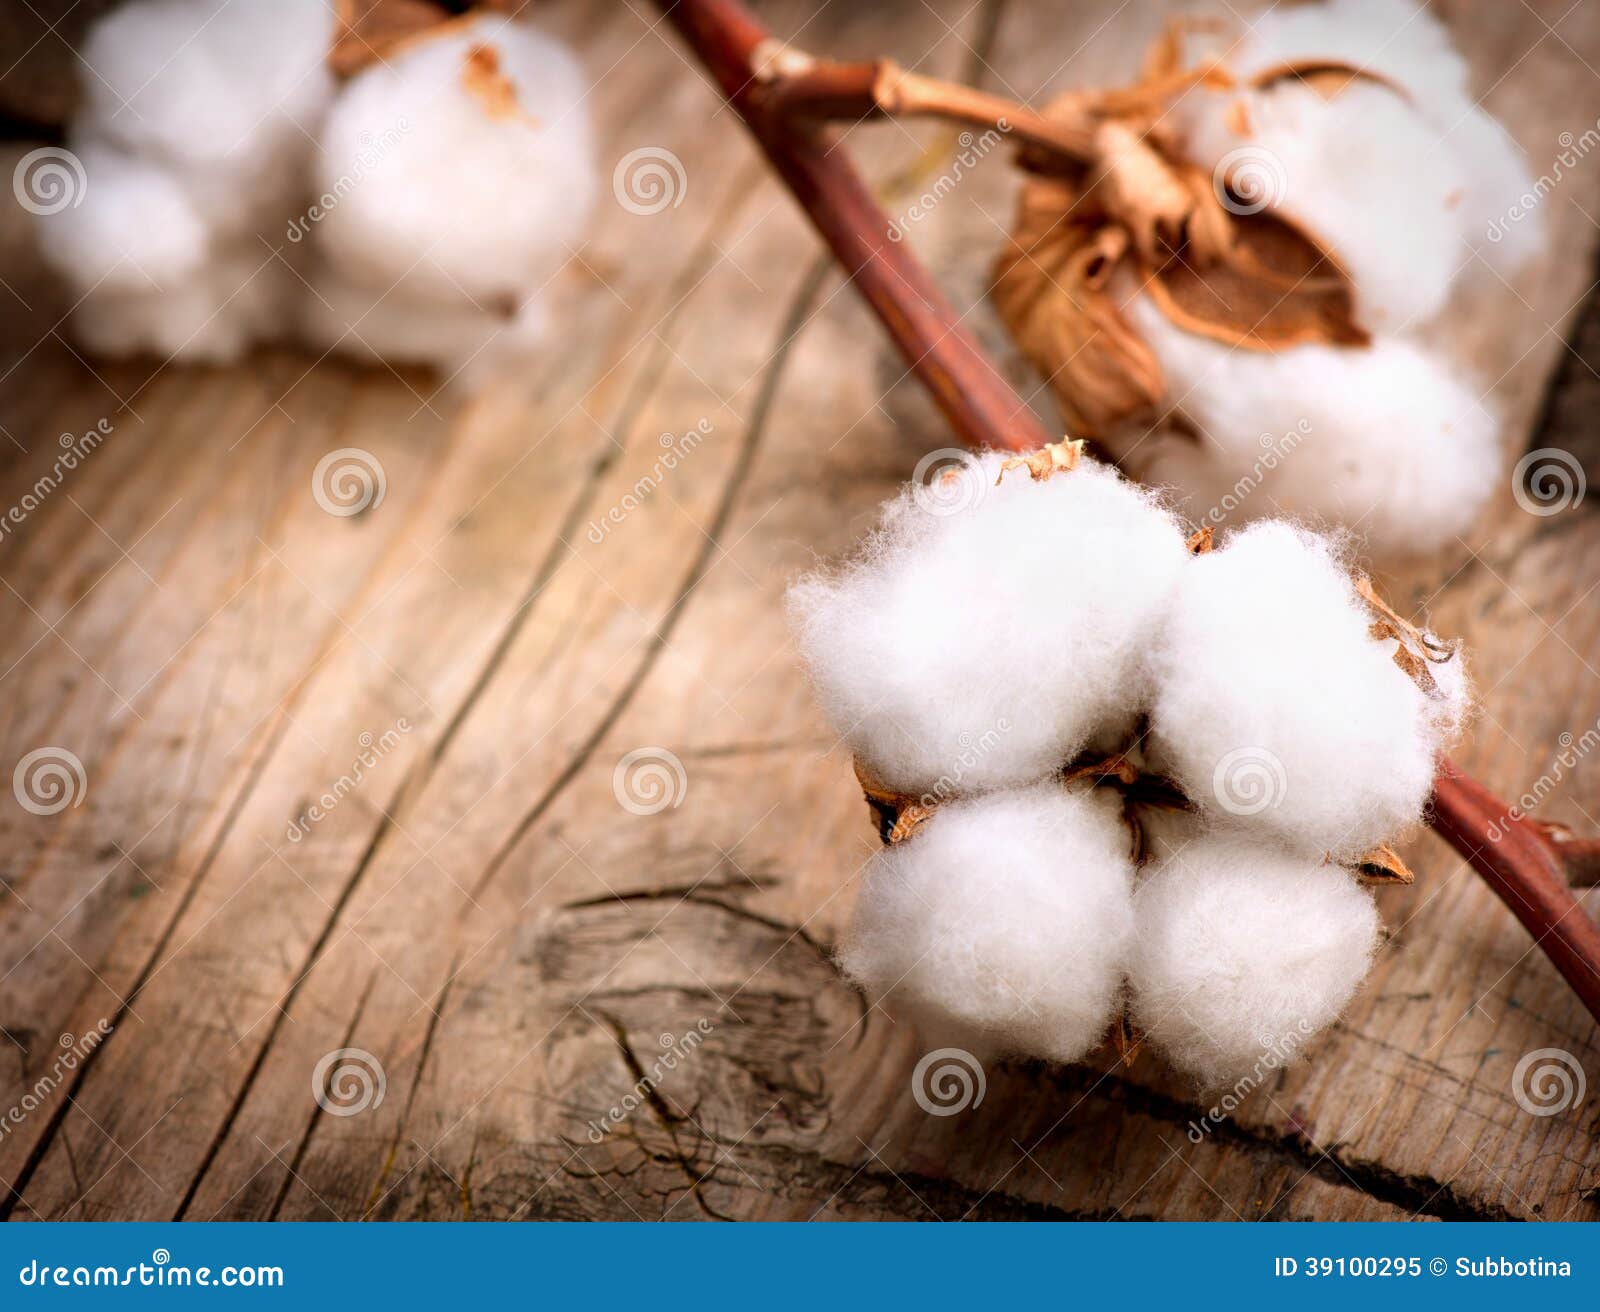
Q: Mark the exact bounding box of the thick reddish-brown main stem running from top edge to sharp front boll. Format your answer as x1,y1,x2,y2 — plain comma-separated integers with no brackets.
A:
659,0,1050,451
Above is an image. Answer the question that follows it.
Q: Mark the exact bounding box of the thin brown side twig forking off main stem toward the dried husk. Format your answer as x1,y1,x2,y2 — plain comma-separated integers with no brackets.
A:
765,59,1094,165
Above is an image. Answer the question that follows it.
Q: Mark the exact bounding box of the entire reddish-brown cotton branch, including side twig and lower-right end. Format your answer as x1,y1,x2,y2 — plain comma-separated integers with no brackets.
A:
658,0,1600,1021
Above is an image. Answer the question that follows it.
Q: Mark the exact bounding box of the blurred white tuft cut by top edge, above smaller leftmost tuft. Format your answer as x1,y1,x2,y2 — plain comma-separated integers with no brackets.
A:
82,0,334,179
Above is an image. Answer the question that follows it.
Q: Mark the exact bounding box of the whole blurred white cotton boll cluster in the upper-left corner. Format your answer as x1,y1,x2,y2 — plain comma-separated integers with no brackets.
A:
38,0,597,386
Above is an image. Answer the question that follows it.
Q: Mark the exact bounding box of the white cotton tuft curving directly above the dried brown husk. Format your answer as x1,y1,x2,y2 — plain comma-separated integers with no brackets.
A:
1184,82,1470,333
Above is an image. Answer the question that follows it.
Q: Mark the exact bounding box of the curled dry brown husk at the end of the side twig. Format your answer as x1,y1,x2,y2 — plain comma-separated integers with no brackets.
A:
992,29,1387,437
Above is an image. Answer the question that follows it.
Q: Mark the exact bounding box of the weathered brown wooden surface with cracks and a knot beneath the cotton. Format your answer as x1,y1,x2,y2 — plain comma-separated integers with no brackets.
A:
0,0,1600,1219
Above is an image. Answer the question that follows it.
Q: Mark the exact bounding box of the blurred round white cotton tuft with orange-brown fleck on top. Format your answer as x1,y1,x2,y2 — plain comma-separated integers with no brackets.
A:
315,18,597,309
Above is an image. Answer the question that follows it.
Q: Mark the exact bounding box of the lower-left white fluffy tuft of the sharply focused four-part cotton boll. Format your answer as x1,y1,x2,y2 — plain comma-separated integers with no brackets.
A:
840,782,1133,1061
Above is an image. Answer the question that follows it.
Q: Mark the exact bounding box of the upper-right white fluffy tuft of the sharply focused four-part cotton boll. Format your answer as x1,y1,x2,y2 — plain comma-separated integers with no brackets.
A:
1149,522,1442,861
